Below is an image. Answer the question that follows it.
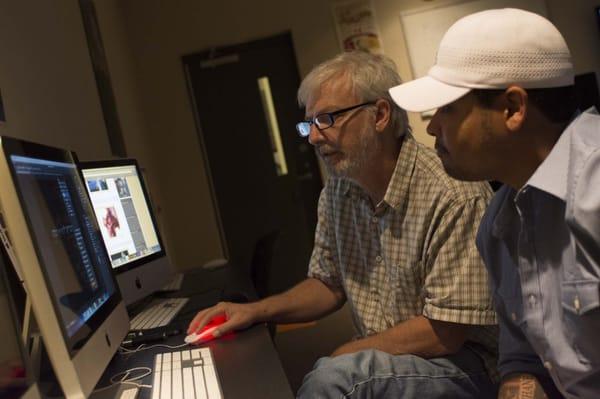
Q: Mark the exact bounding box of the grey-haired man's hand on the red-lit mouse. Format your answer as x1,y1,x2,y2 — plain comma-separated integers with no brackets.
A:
187,302,257,338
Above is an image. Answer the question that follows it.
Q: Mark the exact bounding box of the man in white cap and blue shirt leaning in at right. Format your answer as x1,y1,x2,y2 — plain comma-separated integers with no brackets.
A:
390,9,600,398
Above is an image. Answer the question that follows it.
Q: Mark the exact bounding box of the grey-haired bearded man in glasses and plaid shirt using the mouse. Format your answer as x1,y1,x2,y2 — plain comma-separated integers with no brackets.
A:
189,52,496,398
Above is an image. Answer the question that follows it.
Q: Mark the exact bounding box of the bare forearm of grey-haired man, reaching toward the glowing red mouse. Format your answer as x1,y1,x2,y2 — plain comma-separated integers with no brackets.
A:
253,278,345,323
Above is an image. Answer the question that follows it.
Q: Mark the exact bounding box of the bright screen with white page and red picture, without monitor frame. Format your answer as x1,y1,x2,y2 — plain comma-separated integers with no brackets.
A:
81,163,162,272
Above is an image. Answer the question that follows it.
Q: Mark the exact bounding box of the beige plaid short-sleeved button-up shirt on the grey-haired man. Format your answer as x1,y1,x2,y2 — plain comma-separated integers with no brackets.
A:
308,134,497,377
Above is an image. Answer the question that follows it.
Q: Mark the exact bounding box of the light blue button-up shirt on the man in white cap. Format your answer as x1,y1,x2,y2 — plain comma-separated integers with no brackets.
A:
477,109,600,398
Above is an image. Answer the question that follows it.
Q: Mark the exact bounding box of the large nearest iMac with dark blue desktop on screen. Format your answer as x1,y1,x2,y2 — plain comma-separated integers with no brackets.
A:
0,137,129,398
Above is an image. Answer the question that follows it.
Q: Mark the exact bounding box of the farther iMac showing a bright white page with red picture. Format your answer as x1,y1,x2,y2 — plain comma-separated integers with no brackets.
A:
79,159,172,305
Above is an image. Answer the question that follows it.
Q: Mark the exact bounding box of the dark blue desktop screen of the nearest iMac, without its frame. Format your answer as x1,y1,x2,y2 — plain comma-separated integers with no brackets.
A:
10,155,116,349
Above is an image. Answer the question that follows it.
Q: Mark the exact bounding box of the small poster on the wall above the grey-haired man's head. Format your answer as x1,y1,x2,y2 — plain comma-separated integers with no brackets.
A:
332,0,383,54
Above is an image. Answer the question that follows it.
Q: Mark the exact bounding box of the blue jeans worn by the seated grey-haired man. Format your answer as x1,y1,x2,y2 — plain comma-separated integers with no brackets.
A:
298,348,498,399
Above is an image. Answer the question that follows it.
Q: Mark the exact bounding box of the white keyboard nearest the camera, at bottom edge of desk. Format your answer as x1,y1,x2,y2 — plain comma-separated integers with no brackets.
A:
152,348,223,399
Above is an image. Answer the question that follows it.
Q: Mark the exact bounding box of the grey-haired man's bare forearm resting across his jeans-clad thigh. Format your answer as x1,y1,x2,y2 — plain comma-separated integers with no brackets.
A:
333,316,469,358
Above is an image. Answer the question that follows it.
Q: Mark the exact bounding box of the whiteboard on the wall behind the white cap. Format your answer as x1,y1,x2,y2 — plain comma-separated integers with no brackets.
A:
400,0,547,79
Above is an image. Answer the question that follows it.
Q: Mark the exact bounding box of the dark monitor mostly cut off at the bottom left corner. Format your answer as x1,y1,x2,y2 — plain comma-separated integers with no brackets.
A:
0,245,41,399
